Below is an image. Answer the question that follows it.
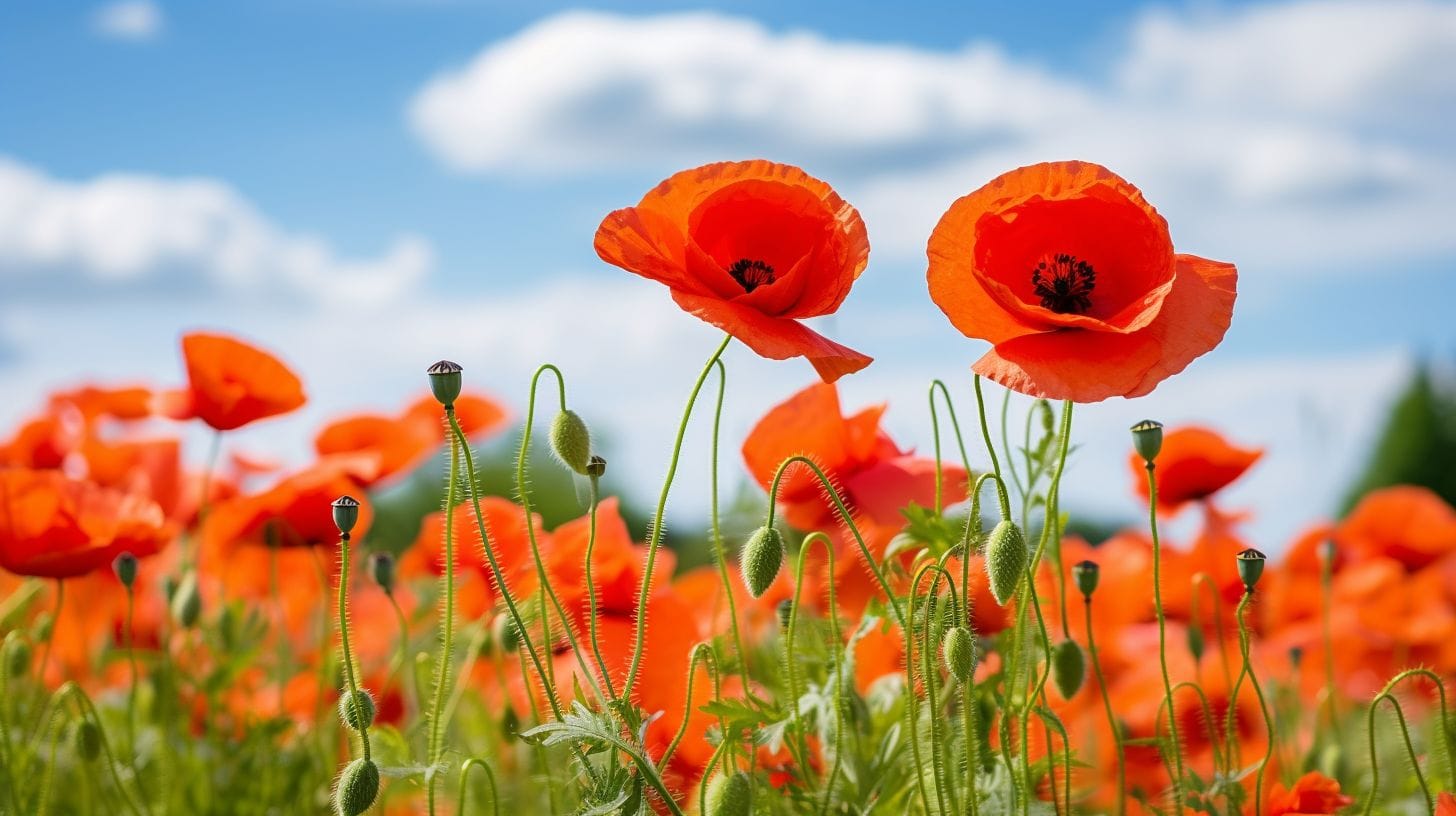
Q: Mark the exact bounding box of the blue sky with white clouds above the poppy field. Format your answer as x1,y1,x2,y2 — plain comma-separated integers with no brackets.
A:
0,0,1456,549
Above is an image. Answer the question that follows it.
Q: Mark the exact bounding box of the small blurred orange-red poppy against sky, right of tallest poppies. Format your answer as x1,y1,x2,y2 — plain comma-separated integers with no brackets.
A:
1128,425,1264,513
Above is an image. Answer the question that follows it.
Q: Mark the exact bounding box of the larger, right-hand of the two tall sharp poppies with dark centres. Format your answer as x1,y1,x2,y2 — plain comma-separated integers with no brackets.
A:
926,162,1238,402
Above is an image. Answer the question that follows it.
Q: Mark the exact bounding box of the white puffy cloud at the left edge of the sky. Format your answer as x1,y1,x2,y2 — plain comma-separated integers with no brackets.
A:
0,156,432,302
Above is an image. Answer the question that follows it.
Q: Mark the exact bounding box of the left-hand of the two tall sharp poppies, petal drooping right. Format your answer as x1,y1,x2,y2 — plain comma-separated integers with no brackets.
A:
596,160,871,382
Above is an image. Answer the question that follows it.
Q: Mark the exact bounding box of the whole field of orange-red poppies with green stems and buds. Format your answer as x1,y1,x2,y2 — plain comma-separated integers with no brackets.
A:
0,160,1456,816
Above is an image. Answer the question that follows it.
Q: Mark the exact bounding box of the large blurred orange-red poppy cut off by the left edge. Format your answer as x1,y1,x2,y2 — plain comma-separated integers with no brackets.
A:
0,469,172,578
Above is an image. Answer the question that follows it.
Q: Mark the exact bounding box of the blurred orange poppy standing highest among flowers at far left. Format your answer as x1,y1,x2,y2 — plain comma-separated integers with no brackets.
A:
165,332,304,431
